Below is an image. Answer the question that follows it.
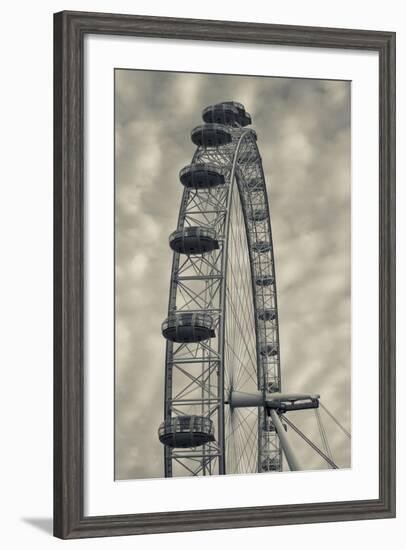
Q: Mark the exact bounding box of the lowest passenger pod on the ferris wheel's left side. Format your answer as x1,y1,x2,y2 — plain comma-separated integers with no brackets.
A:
158,415,215,449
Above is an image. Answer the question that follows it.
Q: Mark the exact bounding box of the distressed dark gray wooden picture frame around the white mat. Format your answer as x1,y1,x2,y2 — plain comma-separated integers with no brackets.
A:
54,12,395,539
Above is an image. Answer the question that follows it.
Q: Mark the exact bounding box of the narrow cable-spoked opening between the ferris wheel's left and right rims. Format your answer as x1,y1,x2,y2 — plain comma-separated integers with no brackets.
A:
224,157,260,474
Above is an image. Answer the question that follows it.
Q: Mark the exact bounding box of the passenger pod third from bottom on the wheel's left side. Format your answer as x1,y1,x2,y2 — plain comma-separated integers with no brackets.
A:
169,227,219,255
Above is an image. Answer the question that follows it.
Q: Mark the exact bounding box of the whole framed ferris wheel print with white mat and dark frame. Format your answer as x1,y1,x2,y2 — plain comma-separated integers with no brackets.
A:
54,12,395,538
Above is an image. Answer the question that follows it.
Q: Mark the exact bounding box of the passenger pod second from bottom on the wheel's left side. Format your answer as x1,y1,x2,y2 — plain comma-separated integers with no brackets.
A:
162,312,216,344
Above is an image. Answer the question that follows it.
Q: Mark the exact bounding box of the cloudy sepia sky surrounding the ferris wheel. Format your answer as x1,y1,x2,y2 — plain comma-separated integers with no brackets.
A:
115,70,351,479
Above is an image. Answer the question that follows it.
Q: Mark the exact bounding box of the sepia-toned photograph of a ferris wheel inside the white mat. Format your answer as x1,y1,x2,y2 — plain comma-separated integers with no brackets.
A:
114,68,352,481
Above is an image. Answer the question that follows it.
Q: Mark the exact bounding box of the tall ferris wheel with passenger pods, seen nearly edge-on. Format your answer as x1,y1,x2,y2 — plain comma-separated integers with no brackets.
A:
158,101,334,477
